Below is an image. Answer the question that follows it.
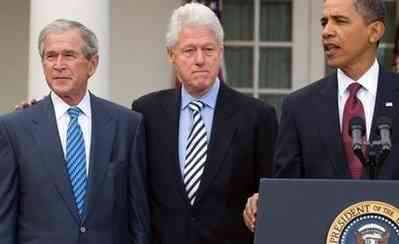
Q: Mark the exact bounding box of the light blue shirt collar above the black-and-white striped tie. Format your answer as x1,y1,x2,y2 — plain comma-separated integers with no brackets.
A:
181,78,220,110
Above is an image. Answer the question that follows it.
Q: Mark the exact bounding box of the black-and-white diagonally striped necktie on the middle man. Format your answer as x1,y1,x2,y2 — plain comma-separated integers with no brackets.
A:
183,101,208,205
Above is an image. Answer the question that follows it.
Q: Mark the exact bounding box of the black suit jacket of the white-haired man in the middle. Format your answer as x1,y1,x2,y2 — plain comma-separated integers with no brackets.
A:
132,82,277,244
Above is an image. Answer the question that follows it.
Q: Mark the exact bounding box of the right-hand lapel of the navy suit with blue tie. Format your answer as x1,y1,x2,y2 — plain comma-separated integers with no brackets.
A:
86,94,115,218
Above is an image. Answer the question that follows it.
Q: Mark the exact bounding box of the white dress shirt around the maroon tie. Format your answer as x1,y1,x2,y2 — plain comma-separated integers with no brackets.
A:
337,60,380,141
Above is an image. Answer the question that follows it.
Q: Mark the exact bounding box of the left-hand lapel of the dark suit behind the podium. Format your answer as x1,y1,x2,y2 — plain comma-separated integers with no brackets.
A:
313,73,350,178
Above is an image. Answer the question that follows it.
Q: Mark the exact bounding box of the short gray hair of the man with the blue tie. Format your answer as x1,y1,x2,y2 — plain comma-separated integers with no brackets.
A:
39,19,98,60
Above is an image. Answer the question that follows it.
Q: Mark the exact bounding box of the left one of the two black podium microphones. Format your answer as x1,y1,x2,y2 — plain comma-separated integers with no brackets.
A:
348,117,366,164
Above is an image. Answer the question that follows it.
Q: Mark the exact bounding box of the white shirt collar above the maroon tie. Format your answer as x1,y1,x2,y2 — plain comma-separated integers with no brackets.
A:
337,59,380,96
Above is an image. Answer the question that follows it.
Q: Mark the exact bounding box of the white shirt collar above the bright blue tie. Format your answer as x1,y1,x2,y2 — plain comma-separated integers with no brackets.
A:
50,90,91,120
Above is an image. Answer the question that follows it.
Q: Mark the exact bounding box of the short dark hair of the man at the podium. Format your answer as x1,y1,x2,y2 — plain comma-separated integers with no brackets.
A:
353,0,385,24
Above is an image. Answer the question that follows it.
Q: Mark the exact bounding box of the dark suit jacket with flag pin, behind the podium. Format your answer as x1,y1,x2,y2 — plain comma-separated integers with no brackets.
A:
274,71,399,179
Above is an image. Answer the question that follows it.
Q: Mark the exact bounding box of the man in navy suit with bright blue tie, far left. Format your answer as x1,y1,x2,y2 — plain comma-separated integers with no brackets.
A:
0,20,151,244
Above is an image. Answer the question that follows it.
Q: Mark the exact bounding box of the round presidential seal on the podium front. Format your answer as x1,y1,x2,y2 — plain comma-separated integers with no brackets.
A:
326,201,399,244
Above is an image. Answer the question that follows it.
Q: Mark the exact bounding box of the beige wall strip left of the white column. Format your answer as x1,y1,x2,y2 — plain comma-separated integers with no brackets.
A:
0,0,29,114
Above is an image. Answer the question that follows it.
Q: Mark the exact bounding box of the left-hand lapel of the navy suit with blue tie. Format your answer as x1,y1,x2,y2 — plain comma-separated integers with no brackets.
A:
32,96,80,223
